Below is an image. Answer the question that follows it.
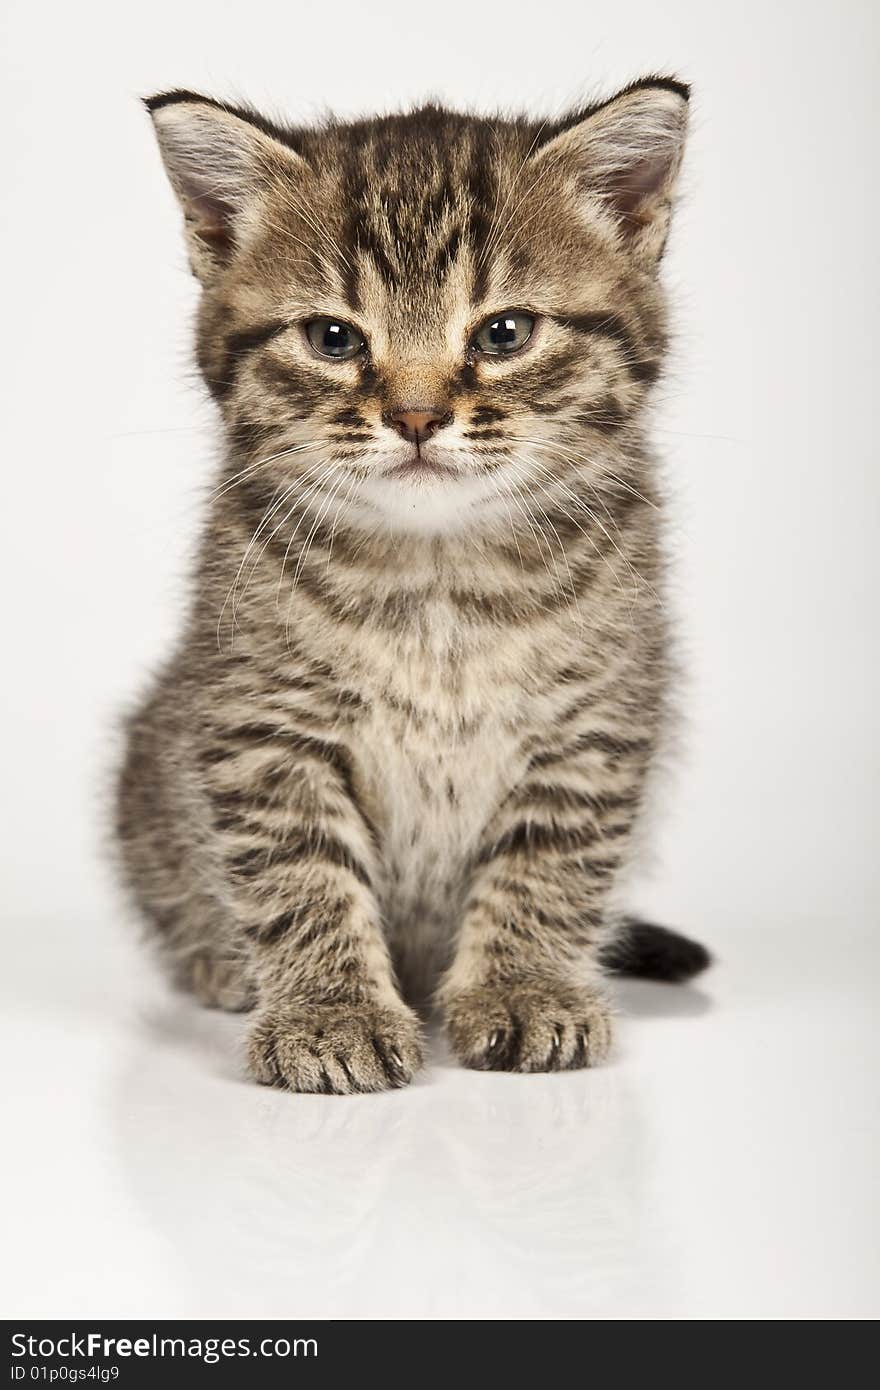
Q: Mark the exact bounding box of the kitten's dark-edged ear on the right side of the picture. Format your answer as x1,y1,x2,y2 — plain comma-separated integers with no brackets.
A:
535,78,690,268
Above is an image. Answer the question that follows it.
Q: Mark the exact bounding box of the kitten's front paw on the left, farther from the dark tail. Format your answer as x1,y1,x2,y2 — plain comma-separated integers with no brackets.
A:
249,1004,423,1095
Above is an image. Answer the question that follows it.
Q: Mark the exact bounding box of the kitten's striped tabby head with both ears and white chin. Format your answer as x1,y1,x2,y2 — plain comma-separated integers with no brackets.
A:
147,78,688,532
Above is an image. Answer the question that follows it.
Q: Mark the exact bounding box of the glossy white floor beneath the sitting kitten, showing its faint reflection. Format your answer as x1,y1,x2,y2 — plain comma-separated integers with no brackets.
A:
3,923,880,1319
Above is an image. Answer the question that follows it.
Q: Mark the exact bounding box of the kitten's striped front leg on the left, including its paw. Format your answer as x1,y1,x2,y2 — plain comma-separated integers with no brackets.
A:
204,724,423,1094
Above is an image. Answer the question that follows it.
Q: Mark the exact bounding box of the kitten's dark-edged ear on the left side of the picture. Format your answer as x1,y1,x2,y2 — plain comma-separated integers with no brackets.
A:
145,92,304,281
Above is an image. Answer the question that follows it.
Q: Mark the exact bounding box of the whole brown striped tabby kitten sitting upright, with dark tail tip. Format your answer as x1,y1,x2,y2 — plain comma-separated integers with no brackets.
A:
118,78,708,1093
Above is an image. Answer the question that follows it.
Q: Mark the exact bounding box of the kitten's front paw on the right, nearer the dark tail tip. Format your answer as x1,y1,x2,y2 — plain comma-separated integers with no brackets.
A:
446,981,612,1072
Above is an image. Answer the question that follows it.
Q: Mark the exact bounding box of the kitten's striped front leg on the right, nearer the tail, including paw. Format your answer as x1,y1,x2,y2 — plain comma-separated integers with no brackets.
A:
439,733,645,1072
